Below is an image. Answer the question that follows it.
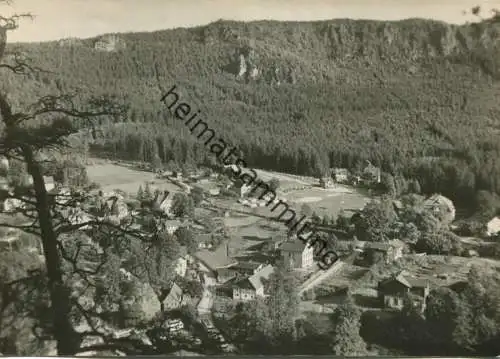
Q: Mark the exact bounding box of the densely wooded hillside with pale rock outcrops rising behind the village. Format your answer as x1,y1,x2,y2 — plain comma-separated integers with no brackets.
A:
0,16,500,211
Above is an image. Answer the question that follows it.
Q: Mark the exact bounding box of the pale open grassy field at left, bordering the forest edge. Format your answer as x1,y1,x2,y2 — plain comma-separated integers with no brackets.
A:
87,161,180,194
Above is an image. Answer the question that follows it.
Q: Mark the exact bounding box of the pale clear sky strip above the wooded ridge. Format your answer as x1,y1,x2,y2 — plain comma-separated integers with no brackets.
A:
0,0,500,42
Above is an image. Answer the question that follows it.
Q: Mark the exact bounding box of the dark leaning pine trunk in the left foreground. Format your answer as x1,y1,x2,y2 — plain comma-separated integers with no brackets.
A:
22,145,81,355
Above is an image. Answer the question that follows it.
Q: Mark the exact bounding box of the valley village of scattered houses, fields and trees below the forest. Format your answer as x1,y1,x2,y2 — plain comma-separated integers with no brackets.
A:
0,153,500,353
